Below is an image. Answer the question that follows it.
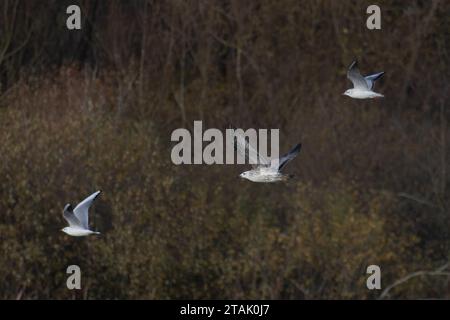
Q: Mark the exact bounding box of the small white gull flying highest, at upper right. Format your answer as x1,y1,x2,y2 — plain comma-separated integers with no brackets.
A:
343,61,384,99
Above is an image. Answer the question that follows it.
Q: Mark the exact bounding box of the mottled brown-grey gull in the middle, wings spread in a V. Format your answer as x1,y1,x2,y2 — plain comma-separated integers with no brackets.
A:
235,134,302,182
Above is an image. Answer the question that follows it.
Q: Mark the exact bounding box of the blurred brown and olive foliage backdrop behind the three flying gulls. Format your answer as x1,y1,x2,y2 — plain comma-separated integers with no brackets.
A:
0,0,450,299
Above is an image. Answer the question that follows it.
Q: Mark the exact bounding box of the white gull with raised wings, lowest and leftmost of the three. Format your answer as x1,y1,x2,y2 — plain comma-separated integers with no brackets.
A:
62,191,101,237
